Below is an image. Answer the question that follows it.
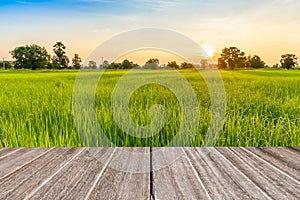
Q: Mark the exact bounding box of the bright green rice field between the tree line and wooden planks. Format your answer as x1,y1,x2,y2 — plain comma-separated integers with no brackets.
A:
0,70,300,147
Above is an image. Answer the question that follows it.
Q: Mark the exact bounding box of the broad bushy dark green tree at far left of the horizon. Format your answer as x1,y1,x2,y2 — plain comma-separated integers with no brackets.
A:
10,44,50,70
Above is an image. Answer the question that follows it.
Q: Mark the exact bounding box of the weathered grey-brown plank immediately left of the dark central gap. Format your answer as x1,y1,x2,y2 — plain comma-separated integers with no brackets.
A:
89,148,150,200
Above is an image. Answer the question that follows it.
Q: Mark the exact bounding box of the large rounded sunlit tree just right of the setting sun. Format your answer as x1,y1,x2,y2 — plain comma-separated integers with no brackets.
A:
217,47,247,69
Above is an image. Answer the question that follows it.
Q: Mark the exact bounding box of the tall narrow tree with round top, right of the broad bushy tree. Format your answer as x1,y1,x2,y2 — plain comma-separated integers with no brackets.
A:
52,42,70,69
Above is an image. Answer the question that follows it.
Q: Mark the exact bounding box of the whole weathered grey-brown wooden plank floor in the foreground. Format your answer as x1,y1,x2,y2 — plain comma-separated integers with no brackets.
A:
0,147,300,200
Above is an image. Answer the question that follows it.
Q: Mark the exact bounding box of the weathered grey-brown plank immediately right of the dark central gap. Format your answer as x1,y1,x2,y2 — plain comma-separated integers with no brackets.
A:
153,148,210,199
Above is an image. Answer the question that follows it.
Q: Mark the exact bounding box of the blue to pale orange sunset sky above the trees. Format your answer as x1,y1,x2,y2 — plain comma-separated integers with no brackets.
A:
0,0,300,65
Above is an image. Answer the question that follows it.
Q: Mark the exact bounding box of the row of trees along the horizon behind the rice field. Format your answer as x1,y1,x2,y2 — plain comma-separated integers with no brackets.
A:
0,42,298,70
